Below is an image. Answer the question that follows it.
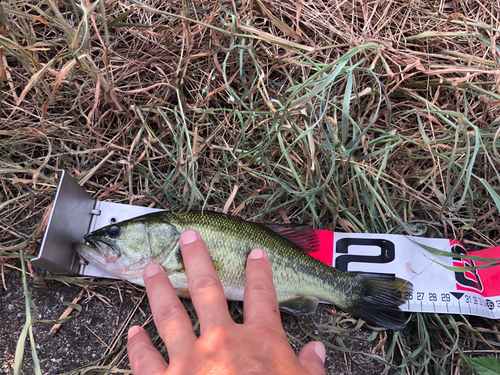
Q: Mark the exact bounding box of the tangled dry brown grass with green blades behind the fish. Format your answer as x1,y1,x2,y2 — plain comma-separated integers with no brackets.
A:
0,0,500,373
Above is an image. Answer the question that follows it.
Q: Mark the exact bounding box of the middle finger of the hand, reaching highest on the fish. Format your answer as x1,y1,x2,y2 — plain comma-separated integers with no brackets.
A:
179,230,233,334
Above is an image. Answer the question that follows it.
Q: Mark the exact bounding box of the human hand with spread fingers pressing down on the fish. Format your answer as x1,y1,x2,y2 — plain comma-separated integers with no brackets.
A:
127,230,325,375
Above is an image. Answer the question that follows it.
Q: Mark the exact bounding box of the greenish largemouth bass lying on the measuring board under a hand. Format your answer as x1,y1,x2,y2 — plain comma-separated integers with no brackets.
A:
74,211,413,330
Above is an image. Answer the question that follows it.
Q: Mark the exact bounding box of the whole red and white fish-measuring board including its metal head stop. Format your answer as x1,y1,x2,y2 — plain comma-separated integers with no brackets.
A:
32,170,500,319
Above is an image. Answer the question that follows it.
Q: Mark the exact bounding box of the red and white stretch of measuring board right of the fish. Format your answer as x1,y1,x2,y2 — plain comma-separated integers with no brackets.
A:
309,230,500,319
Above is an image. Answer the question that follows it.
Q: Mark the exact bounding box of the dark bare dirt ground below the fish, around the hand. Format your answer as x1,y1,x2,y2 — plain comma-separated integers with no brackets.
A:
0,262,396,375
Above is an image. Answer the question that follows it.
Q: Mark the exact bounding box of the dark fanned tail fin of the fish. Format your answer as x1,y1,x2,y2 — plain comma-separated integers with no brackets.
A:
345,272,413,330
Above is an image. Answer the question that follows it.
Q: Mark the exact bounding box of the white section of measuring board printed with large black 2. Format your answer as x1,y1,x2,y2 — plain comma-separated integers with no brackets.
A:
333,232,500,319
